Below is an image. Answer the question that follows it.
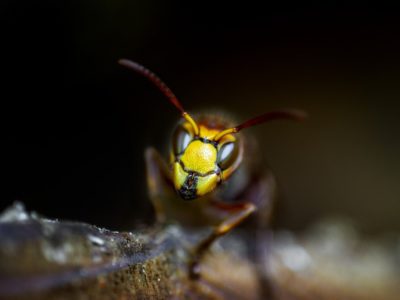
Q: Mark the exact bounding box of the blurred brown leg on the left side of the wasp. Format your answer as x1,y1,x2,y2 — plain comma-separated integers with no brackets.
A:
144,147,171,224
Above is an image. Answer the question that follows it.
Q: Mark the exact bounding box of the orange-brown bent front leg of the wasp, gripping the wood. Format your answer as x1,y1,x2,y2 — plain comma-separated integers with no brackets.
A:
189,203,257,279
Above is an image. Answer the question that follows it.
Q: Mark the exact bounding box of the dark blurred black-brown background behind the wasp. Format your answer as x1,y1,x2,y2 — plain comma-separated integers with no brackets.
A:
0,0,400,233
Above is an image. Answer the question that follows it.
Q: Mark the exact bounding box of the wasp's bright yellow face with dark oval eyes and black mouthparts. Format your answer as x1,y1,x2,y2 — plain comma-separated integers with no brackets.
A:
171,122,242,200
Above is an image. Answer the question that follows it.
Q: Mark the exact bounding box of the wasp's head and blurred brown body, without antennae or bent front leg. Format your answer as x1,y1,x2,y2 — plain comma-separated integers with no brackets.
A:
145,114,275,226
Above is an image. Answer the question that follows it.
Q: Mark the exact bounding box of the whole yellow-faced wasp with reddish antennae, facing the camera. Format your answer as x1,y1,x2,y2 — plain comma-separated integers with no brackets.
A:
119,59,306,278
